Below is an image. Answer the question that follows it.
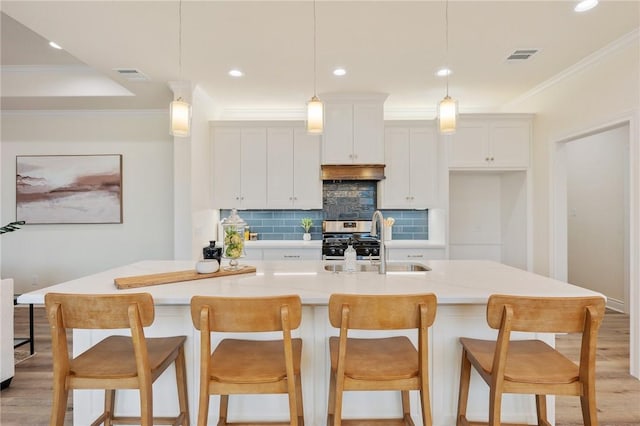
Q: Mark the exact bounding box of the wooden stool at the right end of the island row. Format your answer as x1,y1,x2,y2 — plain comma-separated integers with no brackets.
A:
457,295,605,426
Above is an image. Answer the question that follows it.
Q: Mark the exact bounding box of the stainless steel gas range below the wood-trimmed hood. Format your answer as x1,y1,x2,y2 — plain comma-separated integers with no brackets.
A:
322,220,380,260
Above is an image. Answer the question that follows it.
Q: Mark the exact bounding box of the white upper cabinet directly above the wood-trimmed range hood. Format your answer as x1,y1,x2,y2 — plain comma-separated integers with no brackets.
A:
321,94,387,164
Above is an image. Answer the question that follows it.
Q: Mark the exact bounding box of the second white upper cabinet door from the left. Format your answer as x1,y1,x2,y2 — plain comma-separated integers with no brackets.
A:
241,128,267,209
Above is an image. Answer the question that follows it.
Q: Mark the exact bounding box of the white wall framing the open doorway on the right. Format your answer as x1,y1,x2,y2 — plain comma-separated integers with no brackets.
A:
505,30,640,377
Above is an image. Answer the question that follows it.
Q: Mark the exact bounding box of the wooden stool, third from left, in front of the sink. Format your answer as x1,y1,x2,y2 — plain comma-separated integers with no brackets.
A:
327,294,436,426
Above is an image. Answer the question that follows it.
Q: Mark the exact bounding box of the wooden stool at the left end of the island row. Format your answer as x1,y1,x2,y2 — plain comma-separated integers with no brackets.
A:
45,293,189,426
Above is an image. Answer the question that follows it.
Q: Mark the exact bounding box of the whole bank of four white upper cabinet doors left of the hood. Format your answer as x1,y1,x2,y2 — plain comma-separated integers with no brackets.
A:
211,121,322,209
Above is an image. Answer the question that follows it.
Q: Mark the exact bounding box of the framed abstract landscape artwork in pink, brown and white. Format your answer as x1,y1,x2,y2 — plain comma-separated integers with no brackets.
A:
16,154,122,224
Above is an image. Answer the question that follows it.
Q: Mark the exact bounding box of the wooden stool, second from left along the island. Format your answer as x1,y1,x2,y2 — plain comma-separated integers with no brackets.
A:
191,296,304,426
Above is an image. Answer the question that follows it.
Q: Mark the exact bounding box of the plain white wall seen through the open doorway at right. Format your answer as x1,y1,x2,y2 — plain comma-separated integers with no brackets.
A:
565,126,629,307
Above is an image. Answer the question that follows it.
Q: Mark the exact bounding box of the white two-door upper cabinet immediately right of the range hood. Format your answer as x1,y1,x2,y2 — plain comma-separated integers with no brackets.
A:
379,122,440,209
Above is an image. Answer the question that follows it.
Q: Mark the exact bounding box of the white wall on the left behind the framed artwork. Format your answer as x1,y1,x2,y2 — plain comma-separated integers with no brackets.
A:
1,111,173,293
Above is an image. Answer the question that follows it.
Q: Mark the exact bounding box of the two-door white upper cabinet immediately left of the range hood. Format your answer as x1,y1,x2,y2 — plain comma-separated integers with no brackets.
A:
267,127,322,209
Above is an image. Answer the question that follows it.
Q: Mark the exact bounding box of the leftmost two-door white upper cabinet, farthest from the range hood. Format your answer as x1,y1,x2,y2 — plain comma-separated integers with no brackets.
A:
212,127,267,209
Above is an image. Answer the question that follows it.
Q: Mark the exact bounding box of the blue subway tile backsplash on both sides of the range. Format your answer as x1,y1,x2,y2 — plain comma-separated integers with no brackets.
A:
220,210,429,240
